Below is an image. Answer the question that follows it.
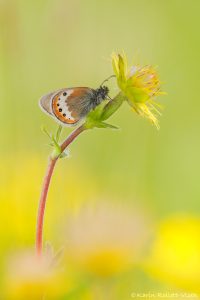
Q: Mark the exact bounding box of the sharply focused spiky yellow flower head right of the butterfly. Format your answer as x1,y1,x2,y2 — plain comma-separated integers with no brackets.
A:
112,53,164,128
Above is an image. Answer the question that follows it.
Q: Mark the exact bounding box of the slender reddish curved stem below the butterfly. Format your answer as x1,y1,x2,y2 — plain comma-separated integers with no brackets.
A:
36,125,86,256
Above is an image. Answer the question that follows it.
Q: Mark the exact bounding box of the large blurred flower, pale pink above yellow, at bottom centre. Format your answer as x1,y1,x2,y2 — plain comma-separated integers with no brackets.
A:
65,202,151,277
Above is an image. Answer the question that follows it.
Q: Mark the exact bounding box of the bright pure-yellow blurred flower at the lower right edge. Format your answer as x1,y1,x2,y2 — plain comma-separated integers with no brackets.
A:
146,215,200,293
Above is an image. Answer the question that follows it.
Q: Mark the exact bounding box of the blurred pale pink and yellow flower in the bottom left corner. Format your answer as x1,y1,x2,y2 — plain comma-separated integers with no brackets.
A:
5,252,70,300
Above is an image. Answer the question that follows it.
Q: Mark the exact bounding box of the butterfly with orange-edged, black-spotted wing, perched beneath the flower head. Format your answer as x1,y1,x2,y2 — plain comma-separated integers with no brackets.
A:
39,77,110,126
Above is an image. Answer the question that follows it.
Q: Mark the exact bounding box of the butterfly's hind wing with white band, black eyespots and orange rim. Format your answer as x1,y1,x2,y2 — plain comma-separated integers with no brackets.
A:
52,87,93,125
